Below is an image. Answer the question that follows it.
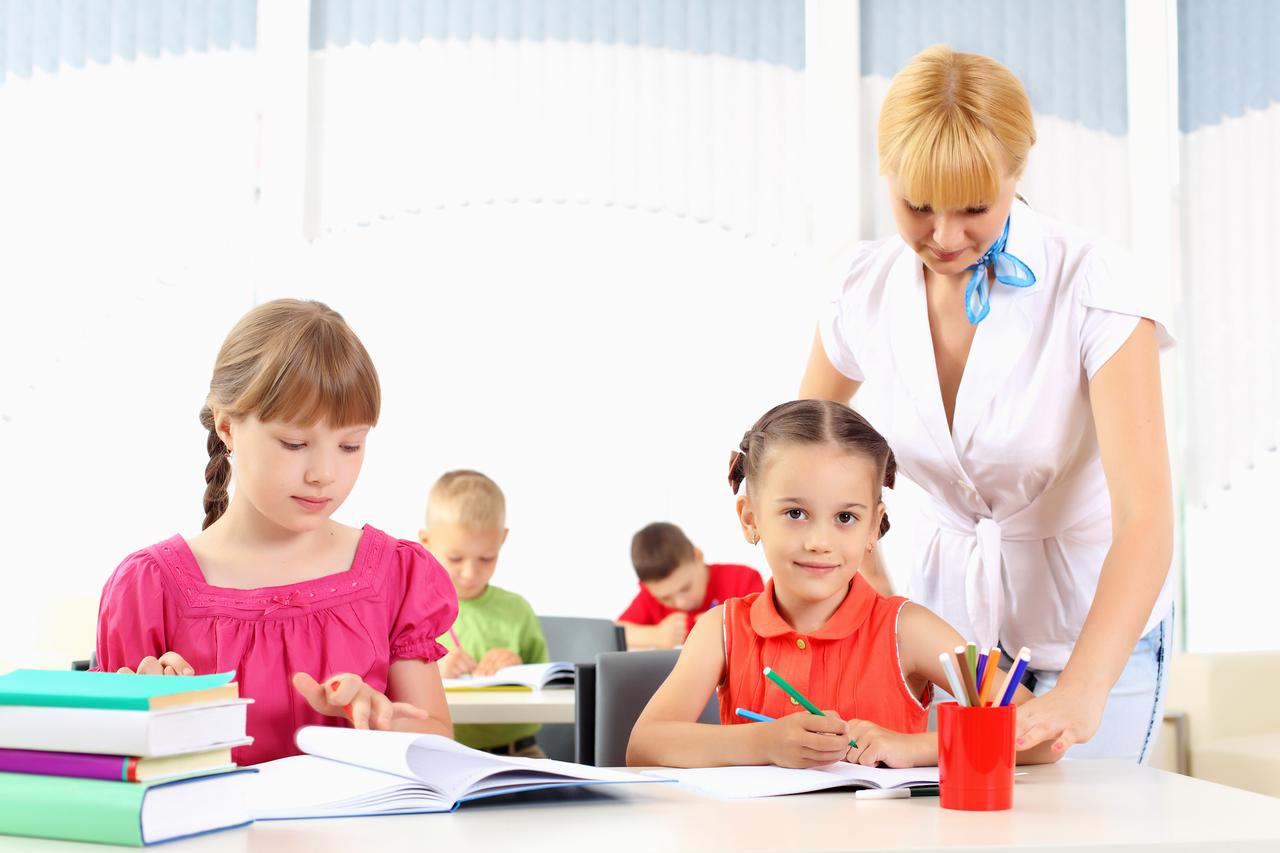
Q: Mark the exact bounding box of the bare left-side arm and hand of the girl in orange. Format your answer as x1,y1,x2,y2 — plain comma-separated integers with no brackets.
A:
627,607,847,767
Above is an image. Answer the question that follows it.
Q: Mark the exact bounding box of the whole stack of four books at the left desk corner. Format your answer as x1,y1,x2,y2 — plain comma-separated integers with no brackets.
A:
0,670,253,847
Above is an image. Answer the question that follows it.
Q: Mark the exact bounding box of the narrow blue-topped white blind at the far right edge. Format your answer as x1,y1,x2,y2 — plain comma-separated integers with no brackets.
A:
1178,0,1280,506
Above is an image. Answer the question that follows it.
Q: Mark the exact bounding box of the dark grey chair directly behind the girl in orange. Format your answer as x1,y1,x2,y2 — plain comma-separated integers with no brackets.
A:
591,648,719,767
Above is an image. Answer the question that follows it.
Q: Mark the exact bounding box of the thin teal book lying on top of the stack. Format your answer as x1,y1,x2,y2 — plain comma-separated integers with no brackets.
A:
0,670,239,711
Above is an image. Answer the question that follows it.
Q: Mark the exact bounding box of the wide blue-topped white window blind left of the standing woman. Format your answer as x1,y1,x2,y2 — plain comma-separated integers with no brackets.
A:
311,0,810,246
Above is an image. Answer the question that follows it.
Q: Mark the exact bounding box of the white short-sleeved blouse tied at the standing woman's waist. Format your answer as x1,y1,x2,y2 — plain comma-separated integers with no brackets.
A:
819,201,1174,670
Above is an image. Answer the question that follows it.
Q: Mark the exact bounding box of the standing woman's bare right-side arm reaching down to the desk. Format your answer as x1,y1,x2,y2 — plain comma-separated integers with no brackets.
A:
1018,319,1174,752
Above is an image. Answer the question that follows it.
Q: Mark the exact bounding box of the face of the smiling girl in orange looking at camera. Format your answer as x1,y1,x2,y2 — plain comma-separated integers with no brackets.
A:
739,444,884,603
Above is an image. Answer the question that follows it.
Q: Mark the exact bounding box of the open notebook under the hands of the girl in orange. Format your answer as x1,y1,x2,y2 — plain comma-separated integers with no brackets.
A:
654,761,938,799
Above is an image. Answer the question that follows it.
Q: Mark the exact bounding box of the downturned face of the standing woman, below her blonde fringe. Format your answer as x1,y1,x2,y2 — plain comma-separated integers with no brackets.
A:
888,174,1018,275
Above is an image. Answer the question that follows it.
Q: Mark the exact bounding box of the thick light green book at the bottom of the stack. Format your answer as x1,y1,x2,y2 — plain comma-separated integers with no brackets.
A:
0,768,257,847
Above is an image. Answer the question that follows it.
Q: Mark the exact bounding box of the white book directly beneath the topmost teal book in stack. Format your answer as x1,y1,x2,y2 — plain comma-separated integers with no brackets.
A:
0,699,253,758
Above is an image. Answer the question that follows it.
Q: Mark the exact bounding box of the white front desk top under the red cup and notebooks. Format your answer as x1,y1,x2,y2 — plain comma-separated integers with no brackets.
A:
0,761,1280,853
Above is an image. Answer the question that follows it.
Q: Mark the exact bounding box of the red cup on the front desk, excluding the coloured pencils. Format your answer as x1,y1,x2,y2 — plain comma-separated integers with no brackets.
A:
938,702,1018,812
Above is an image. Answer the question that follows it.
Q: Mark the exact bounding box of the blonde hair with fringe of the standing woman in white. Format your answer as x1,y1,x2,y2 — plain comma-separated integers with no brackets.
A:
877,45,1036,210
